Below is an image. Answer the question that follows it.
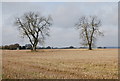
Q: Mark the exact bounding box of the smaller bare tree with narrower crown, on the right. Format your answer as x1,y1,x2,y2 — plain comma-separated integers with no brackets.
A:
75,16,103,50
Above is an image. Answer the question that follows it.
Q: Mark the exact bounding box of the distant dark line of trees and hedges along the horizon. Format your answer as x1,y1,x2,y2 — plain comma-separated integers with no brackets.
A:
0,43,107,50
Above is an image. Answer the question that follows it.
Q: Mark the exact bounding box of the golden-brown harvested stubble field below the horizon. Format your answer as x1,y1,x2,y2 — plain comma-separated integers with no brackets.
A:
2,49,118,79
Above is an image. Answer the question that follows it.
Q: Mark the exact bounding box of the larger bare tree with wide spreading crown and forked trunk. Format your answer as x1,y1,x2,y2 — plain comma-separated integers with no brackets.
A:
15,12,52,51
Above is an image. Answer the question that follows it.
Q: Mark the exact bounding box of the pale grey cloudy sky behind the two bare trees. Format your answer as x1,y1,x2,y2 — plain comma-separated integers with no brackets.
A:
0,2,118,47
